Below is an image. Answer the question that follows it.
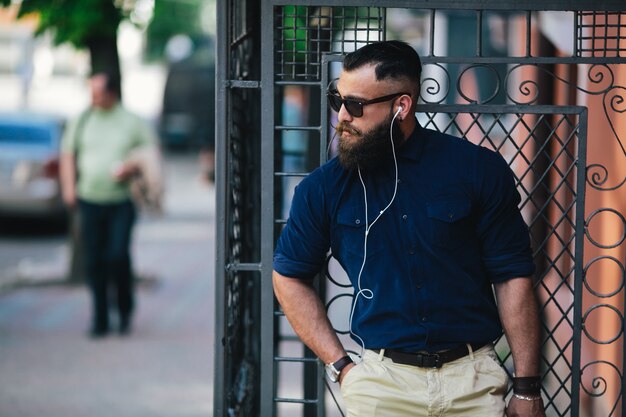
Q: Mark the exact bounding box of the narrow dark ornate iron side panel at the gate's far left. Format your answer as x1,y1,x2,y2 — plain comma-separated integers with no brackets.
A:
214,0,261,417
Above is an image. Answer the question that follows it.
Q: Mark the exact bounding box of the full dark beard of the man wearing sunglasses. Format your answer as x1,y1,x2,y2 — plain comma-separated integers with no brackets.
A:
335,111,404,171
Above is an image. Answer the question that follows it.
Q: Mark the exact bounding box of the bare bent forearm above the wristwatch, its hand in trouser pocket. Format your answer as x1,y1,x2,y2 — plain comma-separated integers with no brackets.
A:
273,271,346,363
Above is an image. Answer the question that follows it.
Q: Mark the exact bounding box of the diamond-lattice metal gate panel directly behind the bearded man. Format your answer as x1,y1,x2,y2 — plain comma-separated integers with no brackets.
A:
326,106,586,416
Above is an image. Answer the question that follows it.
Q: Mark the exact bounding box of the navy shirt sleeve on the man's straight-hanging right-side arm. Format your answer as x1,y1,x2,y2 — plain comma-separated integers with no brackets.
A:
477,148,535,282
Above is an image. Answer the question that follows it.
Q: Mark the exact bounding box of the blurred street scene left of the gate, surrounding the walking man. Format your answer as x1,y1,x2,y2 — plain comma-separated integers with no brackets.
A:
0,0,215,417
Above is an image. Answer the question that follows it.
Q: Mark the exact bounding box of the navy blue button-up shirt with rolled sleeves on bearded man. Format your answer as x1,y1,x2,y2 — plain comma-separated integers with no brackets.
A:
274,126,534,351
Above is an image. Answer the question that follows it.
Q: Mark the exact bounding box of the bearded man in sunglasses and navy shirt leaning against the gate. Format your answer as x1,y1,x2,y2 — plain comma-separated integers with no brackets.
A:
273,41,544,417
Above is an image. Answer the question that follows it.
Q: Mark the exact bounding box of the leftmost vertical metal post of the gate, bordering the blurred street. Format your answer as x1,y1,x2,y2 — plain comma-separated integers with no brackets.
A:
213,2,231,417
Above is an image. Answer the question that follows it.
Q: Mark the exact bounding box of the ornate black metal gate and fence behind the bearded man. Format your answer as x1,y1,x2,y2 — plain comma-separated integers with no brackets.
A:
215,0,626,417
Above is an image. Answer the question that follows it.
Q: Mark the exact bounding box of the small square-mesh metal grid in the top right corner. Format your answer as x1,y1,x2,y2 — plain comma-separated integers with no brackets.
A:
576,11,626,57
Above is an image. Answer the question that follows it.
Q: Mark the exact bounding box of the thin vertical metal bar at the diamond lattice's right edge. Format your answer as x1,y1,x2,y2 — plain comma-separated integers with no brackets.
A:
571,108,587,416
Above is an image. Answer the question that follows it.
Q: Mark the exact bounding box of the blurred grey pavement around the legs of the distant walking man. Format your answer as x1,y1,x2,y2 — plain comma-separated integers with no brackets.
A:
0,154,214,417
